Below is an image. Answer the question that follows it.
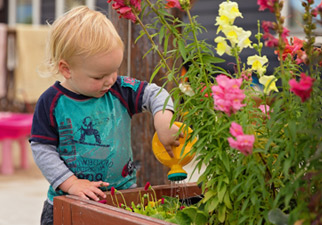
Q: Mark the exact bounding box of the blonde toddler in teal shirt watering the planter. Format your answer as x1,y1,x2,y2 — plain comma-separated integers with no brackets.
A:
30,6,181,224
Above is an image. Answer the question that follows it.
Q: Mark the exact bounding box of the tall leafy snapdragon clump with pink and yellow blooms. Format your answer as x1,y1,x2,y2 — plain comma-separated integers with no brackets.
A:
106,0,322,224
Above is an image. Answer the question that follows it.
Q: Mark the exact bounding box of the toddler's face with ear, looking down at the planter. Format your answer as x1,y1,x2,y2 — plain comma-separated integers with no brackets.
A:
60,49,123,98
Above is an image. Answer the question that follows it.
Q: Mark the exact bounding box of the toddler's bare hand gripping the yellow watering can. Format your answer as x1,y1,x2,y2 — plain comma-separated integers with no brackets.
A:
154,110,183,158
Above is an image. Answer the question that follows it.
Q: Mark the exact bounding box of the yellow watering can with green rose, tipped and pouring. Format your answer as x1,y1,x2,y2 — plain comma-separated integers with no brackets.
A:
152,122,197,181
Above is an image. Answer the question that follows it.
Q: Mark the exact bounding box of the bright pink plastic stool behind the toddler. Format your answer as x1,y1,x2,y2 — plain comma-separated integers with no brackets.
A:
0,112,33,174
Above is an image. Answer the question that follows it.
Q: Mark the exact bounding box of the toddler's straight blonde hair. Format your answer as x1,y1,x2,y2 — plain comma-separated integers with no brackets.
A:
46,6,124,75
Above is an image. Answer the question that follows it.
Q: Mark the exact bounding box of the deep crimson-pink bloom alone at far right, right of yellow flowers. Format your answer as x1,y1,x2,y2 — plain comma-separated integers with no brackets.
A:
289,73,315,102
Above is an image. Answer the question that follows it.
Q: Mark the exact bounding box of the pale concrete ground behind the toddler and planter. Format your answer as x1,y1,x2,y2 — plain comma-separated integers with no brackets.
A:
0,142,203,225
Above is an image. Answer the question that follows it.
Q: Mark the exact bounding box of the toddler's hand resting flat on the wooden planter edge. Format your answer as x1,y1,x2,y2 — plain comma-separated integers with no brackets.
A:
59,176,109,201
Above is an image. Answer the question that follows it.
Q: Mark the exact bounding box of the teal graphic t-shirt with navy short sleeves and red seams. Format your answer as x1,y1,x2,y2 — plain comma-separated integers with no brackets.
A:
30,77,147,201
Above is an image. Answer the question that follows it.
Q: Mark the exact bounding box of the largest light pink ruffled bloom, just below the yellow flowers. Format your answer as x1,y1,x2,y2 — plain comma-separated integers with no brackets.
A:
211,75,246,116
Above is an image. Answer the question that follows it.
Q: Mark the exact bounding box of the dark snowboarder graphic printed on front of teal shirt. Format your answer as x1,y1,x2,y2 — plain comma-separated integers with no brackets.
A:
59,116,115,181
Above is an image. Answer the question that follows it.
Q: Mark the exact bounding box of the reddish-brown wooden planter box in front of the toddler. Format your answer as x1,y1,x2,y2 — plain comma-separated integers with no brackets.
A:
54,183,201,225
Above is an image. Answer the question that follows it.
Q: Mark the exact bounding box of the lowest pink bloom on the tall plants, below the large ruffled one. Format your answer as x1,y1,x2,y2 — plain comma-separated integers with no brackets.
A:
228,135,255,156
